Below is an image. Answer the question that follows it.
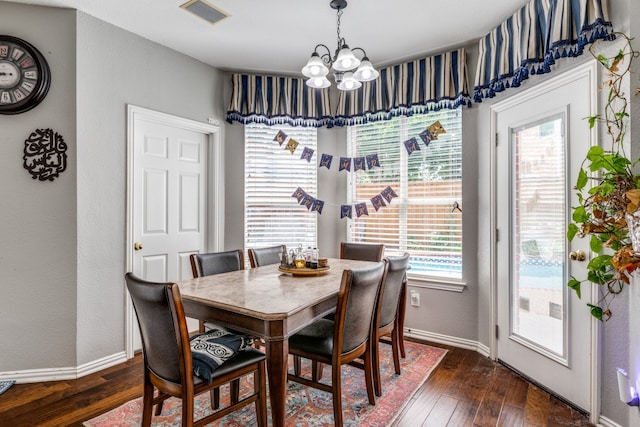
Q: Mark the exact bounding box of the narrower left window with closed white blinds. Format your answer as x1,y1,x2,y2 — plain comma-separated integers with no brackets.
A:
244,124,318,256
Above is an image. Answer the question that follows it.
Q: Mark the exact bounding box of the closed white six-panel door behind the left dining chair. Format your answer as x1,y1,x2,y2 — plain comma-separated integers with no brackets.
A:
129,106,224,351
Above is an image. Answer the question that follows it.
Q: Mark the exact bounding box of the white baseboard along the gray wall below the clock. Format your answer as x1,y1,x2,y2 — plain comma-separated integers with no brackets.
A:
0,352,127,384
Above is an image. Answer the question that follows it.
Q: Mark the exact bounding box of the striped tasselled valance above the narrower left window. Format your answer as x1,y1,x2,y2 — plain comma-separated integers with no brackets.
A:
227,74,333,127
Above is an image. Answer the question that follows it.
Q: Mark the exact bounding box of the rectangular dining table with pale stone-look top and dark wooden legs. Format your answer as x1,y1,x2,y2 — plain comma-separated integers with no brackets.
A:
177,258,374,427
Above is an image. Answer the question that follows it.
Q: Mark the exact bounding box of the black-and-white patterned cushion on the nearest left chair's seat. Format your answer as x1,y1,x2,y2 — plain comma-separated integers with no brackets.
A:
190,329,252,383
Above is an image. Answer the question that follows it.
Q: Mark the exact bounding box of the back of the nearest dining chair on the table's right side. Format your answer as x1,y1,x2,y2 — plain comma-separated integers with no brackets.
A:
336,263,385,354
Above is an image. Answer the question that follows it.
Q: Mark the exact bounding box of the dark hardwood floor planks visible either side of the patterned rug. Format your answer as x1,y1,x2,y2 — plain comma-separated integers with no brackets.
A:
0,344,592,427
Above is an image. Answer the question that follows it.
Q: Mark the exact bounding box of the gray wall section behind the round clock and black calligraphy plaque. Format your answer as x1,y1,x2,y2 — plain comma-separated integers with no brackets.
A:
0,3,77,371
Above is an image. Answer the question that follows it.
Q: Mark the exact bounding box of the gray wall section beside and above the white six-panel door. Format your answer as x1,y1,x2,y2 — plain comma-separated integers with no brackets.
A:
77,13,226,364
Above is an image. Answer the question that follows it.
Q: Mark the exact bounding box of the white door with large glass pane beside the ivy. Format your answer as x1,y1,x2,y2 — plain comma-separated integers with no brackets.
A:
492,64,597,412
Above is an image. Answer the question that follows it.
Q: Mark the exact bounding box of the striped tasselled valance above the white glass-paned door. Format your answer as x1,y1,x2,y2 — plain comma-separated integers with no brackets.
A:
473,0,612,102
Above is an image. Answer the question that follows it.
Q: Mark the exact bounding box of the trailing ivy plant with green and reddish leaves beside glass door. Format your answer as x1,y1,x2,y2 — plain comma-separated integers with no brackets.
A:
567,33,640,321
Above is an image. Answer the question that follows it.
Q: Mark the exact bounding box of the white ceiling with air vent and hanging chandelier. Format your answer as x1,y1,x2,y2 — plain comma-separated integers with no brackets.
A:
6,0,528,75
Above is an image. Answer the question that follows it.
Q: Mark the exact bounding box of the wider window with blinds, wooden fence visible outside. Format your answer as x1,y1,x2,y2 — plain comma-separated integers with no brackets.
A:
347,108,462,279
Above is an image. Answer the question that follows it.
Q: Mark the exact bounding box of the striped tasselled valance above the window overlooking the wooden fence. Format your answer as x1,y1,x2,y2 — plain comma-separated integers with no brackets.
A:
335,49,471,126
